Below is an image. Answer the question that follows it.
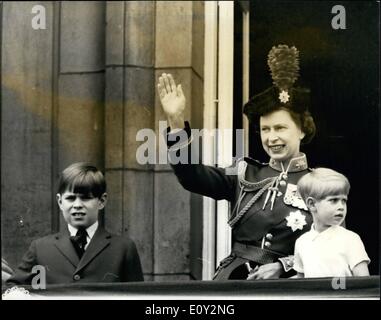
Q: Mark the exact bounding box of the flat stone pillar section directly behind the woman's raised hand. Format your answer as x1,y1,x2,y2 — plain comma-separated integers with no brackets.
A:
154,1,204,281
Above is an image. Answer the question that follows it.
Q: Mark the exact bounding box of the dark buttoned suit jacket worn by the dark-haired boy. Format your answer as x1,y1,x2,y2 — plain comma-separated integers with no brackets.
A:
7,226,143,285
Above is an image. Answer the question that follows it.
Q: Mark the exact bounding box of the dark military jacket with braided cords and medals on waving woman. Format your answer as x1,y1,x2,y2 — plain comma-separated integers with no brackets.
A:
166,124,312,278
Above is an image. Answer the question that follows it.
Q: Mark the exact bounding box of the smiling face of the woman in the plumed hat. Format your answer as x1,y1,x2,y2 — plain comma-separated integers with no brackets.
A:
259,110,305,161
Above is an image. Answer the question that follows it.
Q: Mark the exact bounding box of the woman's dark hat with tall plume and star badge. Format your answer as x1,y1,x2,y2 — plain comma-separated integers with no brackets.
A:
243,45,310,121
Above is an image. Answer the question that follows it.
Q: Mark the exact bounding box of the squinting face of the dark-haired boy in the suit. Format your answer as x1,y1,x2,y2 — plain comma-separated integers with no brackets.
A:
57,191,106,228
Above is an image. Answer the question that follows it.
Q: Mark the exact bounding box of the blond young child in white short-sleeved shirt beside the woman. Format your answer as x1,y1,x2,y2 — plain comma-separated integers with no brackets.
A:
294,168,370,278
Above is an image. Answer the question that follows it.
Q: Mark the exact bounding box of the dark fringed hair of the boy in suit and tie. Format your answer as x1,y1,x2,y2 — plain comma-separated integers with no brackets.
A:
58,162,106,198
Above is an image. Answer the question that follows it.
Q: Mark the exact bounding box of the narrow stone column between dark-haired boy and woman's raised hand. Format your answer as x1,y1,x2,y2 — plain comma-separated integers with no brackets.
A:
105,1,155,280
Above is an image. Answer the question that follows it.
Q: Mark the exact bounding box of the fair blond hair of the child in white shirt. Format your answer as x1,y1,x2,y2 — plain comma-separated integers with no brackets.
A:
298,168,350,201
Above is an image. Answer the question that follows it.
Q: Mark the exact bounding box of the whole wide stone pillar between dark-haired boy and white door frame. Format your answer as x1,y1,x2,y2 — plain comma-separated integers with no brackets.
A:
105,1,203,281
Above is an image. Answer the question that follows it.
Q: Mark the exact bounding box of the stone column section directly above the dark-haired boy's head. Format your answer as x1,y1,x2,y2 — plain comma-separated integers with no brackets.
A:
57,1,105,170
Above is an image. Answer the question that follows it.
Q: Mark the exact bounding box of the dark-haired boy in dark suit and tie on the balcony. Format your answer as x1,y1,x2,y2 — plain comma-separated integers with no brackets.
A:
7,163,143,285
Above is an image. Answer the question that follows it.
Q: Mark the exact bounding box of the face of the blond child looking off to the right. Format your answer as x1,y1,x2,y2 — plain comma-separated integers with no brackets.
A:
311,194,348,230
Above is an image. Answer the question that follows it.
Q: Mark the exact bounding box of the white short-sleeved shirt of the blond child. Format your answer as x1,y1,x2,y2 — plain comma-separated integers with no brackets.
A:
294,224,370,278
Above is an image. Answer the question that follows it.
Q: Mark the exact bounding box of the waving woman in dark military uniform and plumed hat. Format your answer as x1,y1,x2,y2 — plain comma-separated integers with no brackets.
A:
158,45,315,280
